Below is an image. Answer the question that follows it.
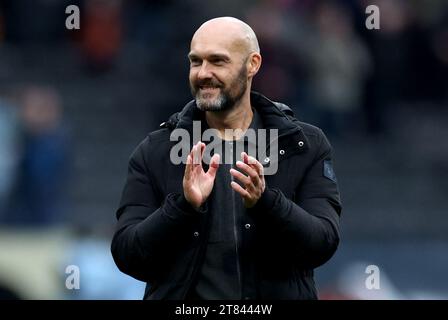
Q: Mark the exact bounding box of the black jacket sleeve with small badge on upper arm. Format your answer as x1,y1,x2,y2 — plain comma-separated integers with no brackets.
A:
251,131,341,268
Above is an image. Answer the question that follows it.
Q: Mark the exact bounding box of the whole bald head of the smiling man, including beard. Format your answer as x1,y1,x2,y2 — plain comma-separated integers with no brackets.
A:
188,17,261,111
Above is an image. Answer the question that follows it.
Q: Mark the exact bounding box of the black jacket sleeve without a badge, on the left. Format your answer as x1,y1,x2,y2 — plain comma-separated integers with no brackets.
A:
111,137,199,282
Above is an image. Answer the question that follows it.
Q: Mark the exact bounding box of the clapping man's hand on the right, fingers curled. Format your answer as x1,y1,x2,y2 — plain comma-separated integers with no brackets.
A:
230,152,266,208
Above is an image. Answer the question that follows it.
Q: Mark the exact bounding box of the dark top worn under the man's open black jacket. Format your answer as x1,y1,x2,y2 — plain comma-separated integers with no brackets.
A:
191,108,263,300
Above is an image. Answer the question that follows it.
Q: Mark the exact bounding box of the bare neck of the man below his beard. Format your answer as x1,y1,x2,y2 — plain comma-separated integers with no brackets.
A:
205,96,254,140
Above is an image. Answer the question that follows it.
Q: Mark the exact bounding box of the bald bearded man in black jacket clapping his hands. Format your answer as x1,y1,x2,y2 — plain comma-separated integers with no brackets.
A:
112,17,341,300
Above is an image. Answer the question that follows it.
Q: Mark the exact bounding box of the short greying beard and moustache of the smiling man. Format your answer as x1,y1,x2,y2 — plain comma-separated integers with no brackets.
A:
190,64,247,111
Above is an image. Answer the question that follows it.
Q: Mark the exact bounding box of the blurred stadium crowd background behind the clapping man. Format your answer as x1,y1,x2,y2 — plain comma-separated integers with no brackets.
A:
0,0,448,299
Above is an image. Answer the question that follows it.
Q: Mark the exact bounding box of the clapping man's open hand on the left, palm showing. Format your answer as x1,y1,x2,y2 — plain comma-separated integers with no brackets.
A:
183,141,219,209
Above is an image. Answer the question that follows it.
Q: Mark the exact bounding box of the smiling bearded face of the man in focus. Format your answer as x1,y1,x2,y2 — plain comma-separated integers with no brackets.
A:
188,30,247,111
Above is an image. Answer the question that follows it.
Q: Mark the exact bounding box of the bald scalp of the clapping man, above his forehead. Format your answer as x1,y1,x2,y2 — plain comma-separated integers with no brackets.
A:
191,17,260,55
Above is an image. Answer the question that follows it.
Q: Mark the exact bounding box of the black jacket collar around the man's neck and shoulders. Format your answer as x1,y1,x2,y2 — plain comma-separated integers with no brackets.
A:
161,91,302,137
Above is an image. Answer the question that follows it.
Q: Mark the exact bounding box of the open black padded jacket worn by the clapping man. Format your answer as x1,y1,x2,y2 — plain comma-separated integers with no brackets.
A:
111,93,341,300
